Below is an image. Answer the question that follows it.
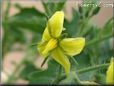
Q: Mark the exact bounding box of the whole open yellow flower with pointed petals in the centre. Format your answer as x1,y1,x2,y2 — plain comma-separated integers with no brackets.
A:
37,11,85,75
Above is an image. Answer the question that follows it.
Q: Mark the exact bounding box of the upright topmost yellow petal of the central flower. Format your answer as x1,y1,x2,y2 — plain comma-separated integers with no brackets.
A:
48,11,64,38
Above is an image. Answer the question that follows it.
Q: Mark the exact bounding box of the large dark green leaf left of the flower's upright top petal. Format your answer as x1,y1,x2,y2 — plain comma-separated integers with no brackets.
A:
9,7,46,33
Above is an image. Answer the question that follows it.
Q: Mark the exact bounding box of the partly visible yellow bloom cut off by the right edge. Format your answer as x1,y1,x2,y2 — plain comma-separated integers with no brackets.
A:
106,58,114,84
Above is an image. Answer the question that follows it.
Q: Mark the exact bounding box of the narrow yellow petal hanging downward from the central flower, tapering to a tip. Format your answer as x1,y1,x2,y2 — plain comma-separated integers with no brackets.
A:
51,47,70,75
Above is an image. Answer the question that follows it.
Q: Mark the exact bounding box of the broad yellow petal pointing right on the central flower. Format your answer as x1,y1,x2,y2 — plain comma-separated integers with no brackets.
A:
60,37,85,56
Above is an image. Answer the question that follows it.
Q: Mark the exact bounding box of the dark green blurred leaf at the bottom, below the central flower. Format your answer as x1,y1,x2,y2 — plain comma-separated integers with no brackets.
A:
29,60,59,84
